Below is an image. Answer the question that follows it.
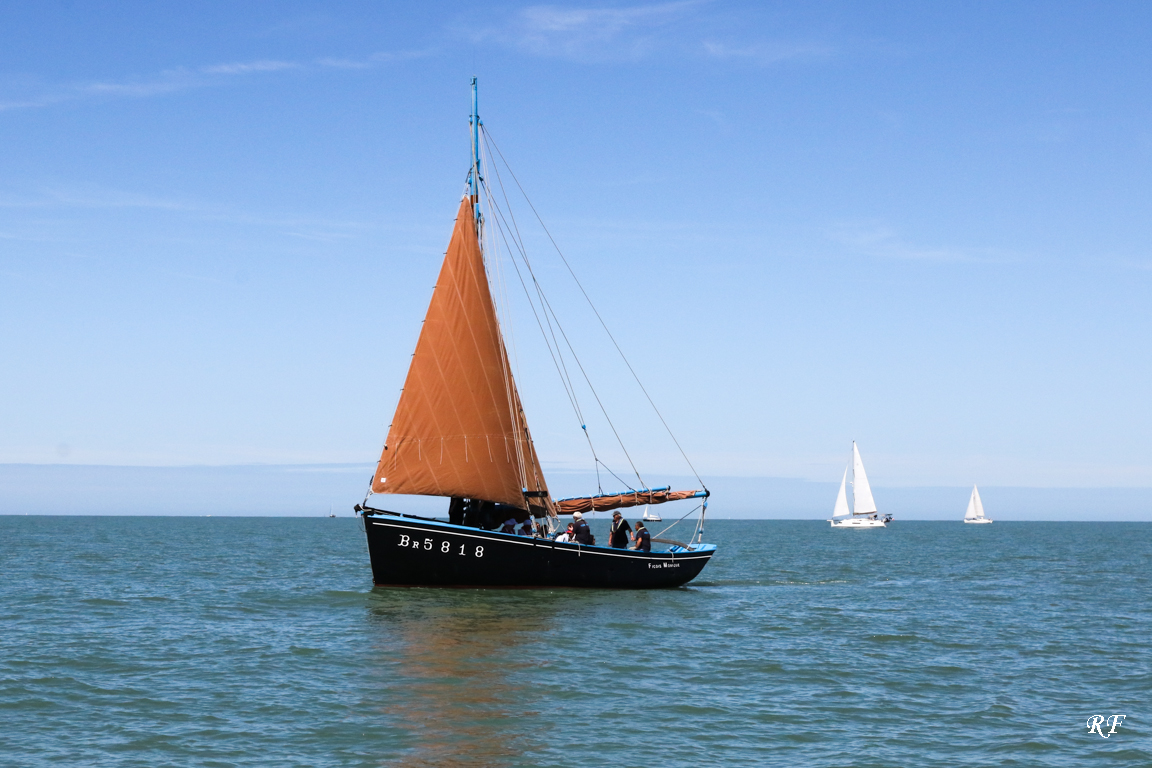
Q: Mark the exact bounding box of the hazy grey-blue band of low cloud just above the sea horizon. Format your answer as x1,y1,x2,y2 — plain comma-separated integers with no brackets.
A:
0,463,1152,522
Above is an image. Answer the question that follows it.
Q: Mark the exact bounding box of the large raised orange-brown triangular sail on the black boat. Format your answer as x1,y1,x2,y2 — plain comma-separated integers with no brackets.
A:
372,197,552,512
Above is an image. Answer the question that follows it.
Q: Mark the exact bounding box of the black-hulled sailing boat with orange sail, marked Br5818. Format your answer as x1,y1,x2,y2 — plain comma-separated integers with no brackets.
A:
356,77,715,587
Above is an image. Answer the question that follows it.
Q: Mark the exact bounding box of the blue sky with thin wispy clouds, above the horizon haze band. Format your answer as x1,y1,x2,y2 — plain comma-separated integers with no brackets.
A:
0,1,1152,490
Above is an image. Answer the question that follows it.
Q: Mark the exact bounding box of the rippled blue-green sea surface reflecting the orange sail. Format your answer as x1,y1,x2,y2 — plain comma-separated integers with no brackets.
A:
0,517,1152,768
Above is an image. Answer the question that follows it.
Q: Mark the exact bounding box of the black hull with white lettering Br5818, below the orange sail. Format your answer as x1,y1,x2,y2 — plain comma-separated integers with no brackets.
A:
364,516,715,590
